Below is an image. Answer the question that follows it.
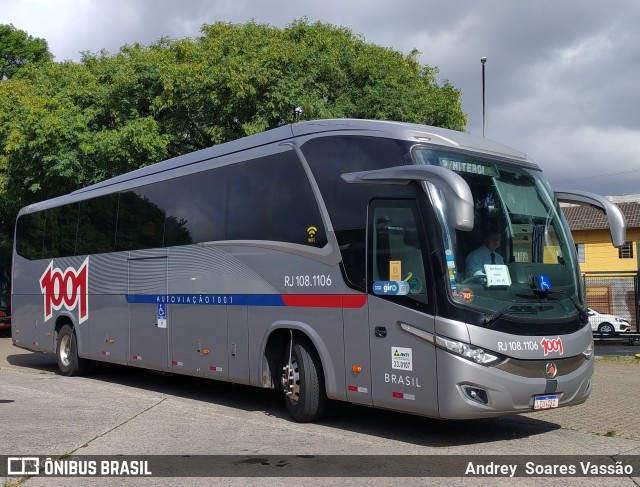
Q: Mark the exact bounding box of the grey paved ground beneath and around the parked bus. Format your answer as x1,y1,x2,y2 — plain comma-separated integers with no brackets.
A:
0,333,640,487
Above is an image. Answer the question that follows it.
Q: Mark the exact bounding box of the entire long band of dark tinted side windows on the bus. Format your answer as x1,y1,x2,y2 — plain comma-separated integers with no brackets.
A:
16,151,327,259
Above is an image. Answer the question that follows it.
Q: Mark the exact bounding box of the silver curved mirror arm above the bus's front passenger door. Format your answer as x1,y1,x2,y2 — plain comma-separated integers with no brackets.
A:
341,165,474,231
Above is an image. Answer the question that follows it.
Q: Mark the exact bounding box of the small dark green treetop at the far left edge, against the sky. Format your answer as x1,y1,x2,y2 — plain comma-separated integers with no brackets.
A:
0,24,53,81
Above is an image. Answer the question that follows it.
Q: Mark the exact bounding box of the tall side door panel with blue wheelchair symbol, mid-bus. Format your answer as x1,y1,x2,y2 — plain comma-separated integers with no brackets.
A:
129,249,170,370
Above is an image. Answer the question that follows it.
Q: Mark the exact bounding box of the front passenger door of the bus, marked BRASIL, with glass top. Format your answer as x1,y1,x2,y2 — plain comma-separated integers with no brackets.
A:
367,199,438,416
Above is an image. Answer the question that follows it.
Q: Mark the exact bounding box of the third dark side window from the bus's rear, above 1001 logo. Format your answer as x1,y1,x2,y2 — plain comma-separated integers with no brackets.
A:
76,194,118,254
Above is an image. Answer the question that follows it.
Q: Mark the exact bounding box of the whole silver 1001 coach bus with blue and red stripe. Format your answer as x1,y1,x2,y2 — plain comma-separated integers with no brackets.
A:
12,120,625,422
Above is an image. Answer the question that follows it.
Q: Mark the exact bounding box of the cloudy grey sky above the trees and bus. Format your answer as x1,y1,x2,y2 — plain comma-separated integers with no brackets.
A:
5,0,640,195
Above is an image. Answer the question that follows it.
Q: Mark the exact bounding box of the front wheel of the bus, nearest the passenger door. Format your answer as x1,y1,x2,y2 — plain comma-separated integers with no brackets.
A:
282,339,326,423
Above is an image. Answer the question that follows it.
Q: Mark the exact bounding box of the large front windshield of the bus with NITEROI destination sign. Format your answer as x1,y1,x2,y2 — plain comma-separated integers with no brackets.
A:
413,148,584,320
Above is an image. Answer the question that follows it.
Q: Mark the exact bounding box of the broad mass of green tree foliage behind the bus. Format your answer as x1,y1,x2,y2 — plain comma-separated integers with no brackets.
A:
0,19,466,266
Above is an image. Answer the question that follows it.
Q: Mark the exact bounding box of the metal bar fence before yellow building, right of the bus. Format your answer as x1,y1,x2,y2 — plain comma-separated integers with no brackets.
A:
583,272,640,332
